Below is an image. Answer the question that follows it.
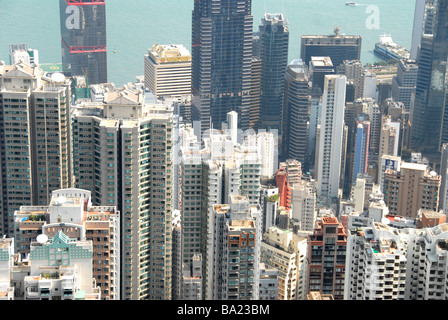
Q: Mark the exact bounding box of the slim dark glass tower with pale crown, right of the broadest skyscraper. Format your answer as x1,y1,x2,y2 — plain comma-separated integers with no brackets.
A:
259,13,289,134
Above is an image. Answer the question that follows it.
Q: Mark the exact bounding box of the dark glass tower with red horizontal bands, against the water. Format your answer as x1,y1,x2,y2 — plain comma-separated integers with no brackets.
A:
59,0,107,84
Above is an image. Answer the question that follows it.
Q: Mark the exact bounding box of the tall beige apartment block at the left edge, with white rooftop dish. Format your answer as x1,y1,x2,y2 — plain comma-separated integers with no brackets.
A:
0,62,73,235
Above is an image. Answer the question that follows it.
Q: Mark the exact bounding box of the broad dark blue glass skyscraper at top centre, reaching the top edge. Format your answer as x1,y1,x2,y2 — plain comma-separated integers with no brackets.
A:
191,0,253,131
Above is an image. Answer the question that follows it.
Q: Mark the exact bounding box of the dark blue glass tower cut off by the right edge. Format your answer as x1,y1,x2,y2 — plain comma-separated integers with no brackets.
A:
411,0,448,160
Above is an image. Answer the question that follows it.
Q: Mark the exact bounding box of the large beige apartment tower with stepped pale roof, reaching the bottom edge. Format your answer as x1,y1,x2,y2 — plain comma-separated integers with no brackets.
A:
73,85,174,300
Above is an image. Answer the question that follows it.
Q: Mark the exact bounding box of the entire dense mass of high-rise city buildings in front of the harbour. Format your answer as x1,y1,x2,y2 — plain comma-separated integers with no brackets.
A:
0,0,448,300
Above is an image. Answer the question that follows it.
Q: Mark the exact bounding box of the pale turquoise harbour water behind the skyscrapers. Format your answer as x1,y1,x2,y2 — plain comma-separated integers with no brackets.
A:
0,0,415,86
